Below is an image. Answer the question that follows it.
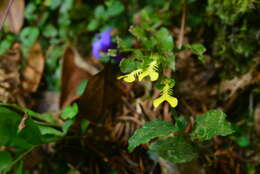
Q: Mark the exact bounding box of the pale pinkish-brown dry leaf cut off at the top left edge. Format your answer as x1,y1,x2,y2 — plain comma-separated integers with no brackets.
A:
7,0,24,34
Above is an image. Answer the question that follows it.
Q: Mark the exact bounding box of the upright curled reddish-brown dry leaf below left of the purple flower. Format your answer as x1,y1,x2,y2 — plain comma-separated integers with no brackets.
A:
60,48,92,108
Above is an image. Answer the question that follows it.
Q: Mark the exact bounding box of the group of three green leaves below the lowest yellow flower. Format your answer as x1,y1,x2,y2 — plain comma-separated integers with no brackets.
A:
128,110,234,163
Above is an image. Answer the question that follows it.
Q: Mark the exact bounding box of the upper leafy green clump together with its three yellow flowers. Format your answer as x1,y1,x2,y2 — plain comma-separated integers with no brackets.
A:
117,8,206,107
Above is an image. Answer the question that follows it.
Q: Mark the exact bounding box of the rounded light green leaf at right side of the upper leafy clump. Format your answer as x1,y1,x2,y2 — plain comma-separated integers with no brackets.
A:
155,28,173,51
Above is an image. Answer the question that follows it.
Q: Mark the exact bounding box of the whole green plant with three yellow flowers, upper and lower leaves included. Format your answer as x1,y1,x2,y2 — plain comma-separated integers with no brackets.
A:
118,9,234,163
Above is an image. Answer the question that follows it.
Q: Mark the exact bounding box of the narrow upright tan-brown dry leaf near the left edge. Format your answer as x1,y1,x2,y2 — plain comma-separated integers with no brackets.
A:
22,42,45,92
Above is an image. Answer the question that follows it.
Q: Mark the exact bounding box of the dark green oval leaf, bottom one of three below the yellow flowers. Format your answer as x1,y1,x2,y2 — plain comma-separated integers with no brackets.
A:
149,137,198,163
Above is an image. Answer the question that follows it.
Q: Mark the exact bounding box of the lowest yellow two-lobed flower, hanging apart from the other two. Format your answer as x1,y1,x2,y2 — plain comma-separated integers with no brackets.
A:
153,83,178,107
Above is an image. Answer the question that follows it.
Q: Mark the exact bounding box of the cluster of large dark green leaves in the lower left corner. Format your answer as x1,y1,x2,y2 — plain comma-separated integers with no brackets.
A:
0,104,88,174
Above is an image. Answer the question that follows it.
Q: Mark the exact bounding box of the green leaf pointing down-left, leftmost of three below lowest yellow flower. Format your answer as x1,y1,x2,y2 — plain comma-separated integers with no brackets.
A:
128,120,177,152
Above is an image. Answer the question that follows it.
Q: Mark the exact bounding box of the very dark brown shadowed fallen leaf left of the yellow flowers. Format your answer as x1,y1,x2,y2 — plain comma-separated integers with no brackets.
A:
79,64,122,122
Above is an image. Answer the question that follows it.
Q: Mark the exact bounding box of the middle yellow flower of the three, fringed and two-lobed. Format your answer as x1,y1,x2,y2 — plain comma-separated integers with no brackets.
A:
138,61,159,81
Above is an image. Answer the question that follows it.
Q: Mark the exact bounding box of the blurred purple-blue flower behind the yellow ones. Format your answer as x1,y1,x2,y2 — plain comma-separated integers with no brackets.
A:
92,28,122,61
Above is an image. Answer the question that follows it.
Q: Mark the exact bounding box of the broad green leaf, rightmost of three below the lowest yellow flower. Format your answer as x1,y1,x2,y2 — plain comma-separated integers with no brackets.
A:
191,110,234,141
